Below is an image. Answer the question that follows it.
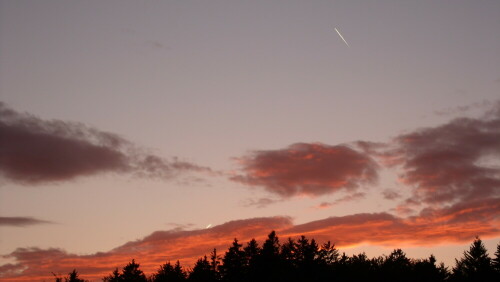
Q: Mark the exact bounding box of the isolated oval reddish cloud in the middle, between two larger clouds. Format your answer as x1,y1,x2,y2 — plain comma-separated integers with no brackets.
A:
232,143,378,197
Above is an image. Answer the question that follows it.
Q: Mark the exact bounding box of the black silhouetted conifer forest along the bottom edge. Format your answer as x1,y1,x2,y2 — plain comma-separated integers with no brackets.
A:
54,231,500,282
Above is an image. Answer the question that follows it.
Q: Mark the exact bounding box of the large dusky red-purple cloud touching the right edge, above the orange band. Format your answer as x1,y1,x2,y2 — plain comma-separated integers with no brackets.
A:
386,104,500,204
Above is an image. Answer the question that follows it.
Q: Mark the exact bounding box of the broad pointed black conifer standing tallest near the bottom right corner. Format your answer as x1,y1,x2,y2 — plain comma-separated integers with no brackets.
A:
451,237,494,282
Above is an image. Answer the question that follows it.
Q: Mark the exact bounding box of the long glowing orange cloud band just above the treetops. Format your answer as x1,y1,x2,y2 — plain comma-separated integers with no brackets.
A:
0,199,500,281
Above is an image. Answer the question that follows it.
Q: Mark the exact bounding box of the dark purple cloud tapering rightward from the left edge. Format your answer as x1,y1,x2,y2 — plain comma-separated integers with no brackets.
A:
0,102,210,184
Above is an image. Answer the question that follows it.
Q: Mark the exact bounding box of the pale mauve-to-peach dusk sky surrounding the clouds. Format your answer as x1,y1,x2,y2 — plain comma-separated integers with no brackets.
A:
0,0,500,278
